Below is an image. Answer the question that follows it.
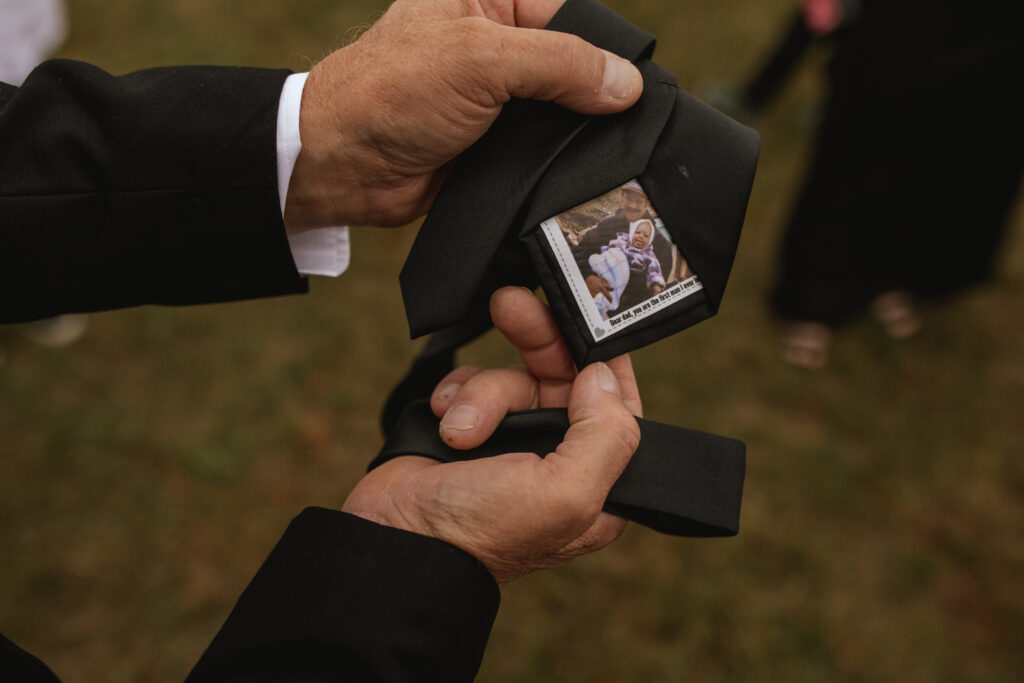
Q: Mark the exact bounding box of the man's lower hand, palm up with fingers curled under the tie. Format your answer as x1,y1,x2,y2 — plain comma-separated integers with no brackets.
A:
342,288,642,584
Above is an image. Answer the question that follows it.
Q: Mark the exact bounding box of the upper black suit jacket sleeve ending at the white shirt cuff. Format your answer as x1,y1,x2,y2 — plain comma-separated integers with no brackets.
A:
0,60,305,323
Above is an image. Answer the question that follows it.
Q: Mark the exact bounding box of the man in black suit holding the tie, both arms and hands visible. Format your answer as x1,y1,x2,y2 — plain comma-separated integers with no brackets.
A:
0,0,643,681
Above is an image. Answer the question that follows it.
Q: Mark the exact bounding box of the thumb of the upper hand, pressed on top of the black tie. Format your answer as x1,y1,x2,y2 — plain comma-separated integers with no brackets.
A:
485,24,643,114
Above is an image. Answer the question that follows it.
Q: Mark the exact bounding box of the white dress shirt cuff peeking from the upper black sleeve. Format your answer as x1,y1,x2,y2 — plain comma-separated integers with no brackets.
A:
278,74,349,278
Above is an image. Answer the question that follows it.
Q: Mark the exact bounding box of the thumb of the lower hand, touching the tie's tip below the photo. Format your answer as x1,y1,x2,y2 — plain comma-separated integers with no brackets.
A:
545,362,640,501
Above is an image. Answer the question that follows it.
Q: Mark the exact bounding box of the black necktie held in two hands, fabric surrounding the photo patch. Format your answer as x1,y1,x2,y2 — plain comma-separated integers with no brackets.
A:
371,0,759,536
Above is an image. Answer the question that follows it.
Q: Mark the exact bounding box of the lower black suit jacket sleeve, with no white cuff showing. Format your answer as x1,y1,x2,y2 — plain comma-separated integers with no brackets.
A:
187,508,499,683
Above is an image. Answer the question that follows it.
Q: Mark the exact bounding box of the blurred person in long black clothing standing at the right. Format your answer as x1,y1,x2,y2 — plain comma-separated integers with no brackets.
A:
772,0,1024,369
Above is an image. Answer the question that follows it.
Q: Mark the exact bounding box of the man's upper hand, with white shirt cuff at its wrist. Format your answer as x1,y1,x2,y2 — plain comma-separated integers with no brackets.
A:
285,0,643,232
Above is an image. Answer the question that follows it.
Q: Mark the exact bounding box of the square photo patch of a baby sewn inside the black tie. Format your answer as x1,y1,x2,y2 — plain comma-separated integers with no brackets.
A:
541,180,703,341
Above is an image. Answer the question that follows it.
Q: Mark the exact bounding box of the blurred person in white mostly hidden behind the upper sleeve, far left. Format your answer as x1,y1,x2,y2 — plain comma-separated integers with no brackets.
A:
0,0,88,352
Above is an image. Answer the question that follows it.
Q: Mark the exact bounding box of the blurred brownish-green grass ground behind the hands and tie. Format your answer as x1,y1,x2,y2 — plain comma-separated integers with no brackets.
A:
0,0,1024,683
